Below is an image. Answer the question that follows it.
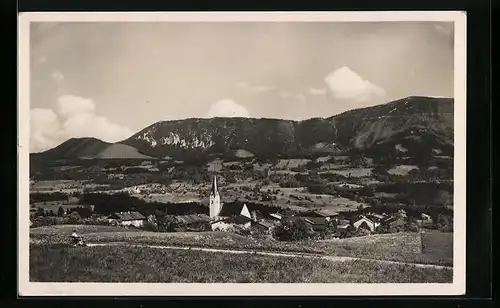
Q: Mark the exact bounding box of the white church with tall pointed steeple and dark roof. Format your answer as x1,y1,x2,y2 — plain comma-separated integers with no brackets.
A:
209,176,252,230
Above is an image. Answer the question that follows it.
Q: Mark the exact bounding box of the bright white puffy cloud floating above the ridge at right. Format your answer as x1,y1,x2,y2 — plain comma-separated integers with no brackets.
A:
325,66,385,102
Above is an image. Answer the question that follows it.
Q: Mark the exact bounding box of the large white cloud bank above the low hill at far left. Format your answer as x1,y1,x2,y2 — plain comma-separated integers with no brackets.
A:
30,95,133,152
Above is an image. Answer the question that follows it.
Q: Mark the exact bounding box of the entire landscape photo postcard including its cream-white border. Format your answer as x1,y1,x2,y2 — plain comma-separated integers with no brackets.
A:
18,12,466,296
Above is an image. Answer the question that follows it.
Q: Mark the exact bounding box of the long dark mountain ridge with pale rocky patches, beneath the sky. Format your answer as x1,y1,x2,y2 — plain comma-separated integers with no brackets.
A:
31,96,454,160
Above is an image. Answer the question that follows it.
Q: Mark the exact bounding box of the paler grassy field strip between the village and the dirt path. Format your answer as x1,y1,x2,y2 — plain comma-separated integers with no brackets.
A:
30,225,453,266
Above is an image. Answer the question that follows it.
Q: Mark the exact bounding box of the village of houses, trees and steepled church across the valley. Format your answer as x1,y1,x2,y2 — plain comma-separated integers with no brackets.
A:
30,176,433,240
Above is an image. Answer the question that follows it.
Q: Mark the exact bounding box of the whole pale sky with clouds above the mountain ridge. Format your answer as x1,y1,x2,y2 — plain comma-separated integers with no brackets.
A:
30,22,454,152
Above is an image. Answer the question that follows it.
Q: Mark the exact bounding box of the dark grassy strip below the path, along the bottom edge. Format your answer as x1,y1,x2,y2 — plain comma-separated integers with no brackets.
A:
30,244,453,283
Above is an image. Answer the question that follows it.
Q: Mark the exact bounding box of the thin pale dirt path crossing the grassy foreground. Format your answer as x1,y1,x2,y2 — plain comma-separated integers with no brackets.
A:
87,242,452,269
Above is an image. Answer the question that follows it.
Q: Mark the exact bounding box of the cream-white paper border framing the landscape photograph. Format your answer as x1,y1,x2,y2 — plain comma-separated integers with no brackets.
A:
18,11,467,296
